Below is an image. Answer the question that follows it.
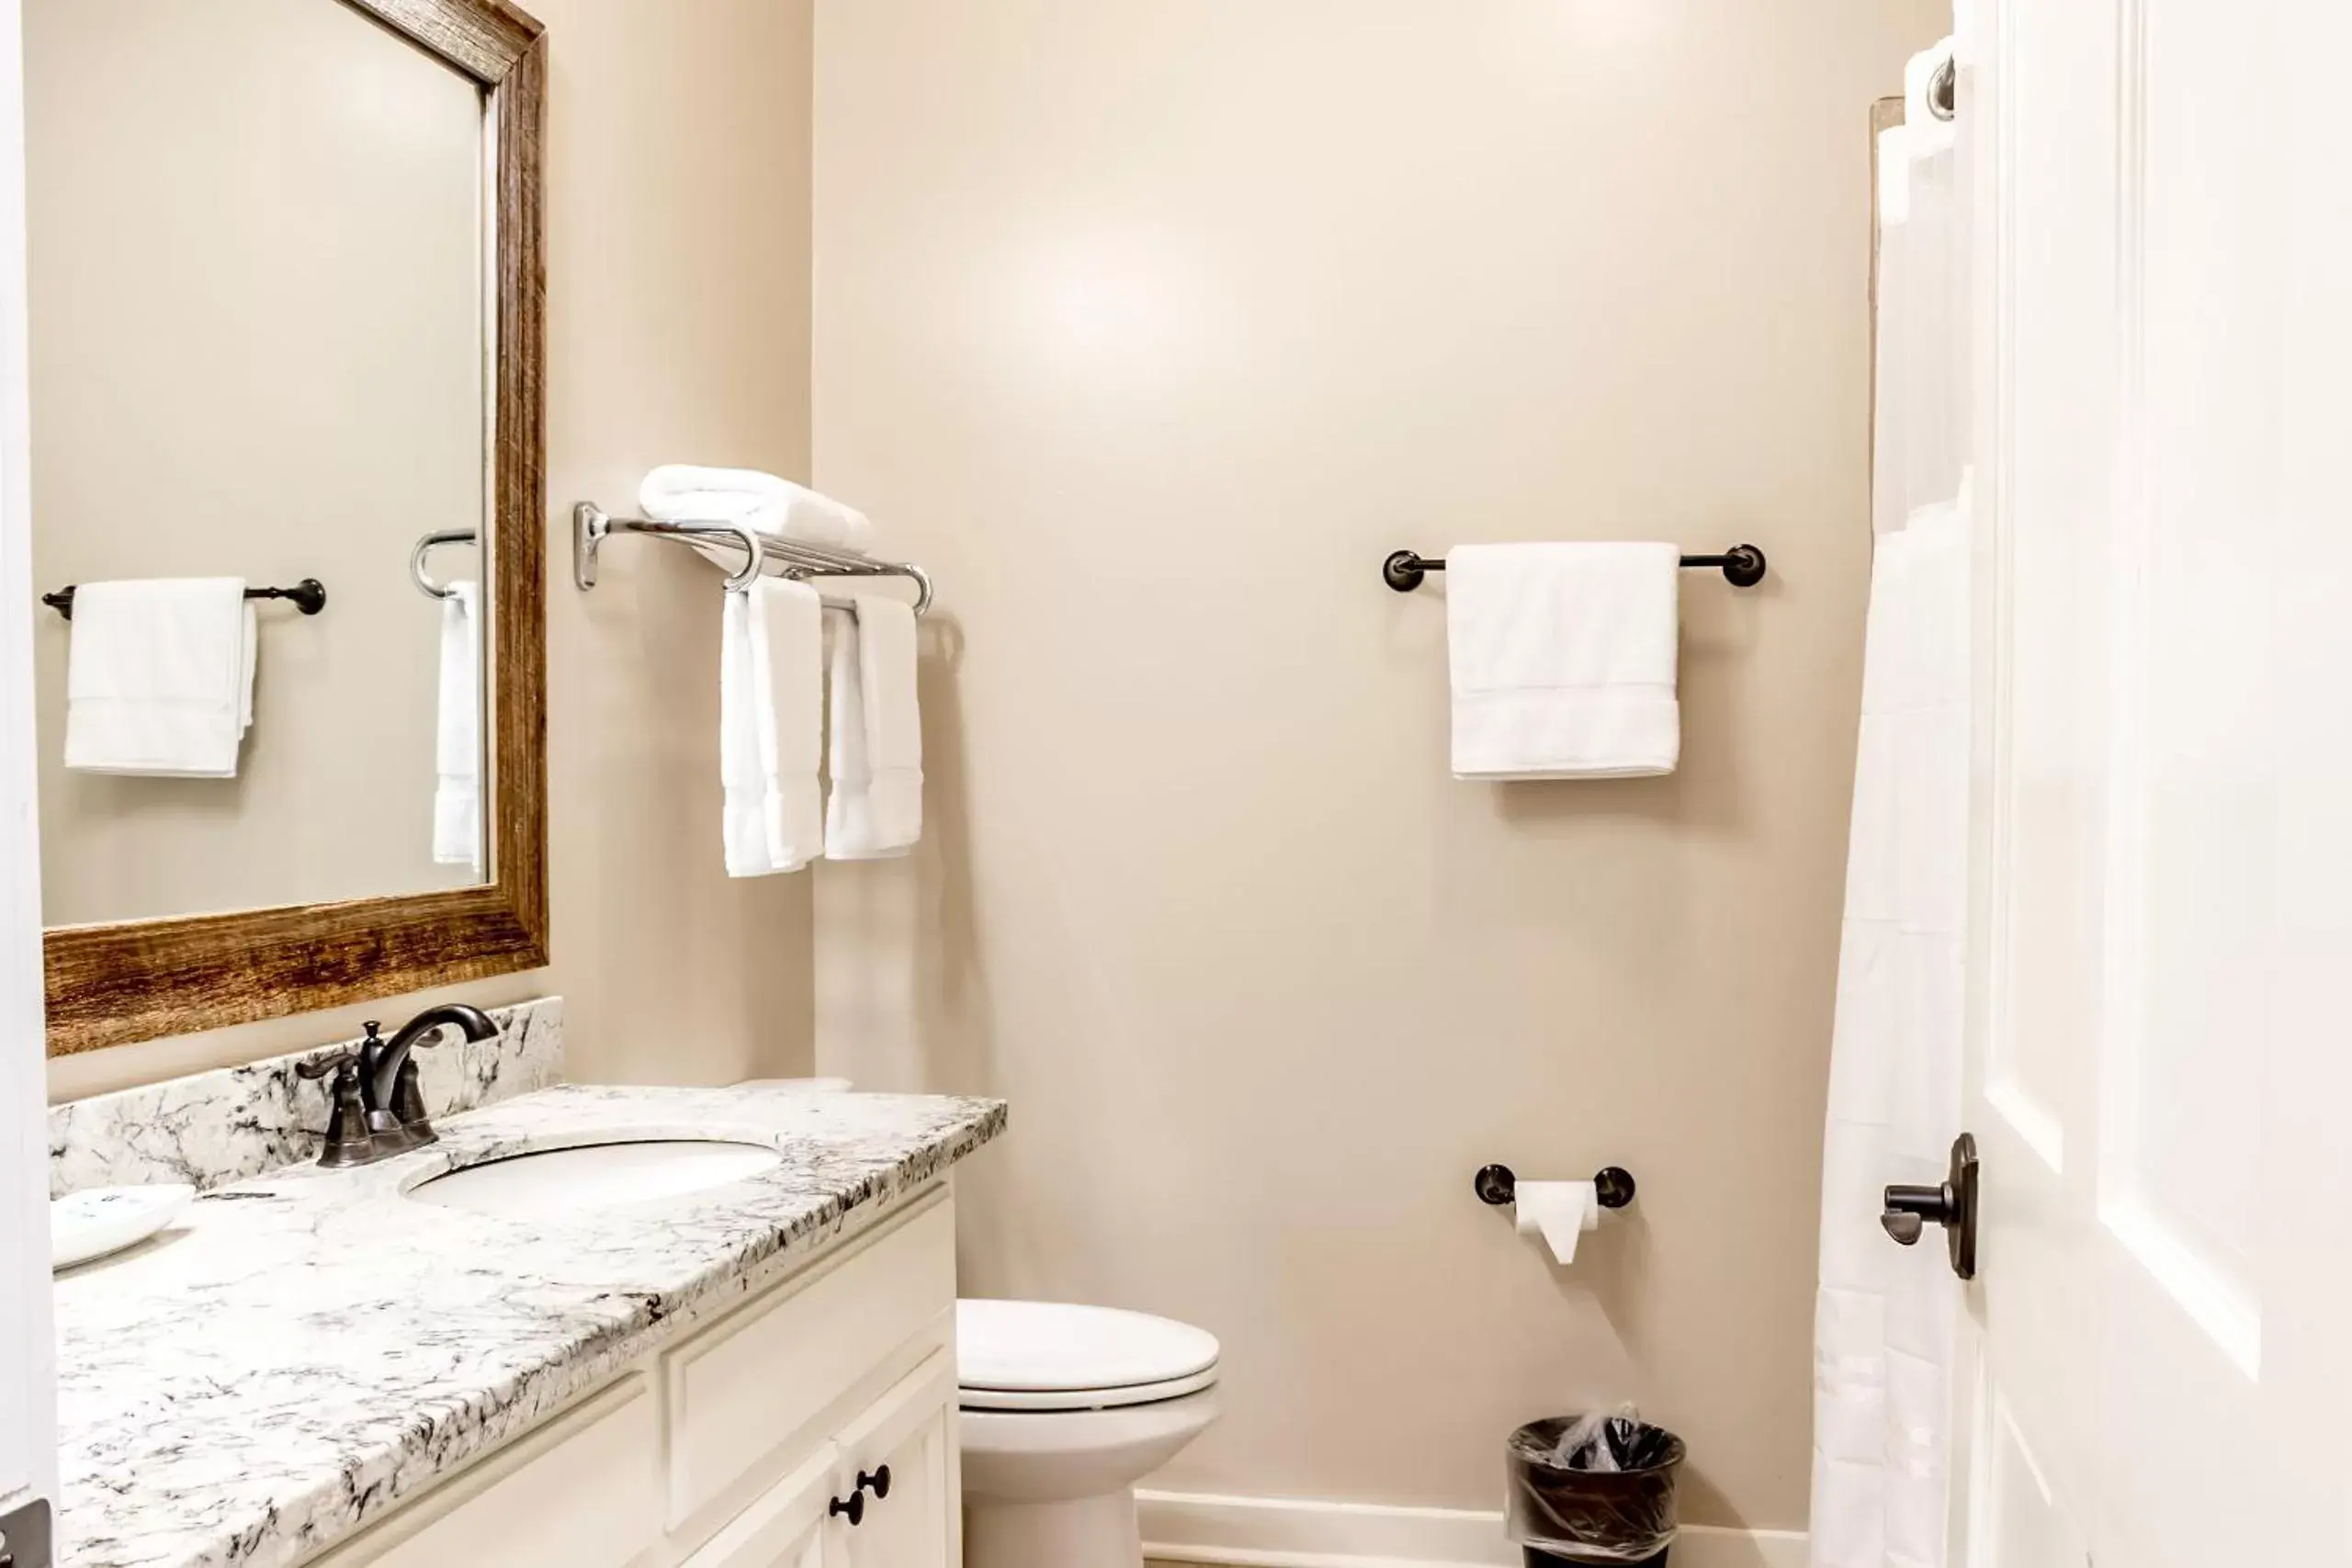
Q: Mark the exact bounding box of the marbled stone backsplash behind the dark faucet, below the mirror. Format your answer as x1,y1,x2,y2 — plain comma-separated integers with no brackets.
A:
50,997,564,1199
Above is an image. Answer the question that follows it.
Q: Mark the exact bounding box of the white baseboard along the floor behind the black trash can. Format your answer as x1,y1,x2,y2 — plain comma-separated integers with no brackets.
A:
1136,1493,1806,1568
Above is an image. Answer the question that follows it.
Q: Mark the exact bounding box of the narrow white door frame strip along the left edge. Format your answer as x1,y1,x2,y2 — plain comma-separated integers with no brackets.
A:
0,0,56,1541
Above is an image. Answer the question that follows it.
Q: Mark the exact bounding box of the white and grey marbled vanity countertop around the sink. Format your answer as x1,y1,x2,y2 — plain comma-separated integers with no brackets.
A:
56,1086,1004,1568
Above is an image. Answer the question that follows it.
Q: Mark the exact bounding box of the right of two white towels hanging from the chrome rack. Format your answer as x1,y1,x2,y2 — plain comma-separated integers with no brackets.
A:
826,594,922,861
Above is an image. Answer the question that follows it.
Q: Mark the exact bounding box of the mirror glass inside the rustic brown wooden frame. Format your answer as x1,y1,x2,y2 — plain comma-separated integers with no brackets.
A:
24,0,489,926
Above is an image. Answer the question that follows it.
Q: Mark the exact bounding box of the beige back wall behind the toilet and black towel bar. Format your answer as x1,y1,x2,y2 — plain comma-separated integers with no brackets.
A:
816,0,1943,1528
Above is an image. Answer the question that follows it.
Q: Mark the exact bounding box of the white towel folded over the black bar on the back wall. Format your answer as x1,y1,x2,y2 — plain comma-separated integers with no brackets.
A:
1446,546,1681,778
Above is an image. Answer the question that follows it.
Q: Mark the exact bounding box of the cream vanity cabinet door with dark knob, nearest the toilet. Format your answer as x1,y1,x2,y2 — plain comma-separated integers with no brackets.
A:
828,1349,950,1568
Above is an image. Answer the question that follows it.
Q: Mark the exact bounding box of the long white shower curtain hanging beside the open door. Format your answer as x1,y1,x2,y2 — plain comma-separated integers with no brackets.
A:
1811,42,1969,1568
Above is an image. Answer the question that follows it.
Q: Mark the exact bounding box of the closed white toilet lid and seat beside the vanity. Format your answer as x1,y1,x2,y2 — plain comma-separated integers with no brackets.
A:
955,1300,1218,1411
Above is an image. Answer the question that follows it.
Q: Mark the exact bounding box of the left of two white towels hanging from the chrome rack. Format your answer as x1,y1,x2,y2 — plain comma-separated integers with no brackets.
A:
719,579,826,877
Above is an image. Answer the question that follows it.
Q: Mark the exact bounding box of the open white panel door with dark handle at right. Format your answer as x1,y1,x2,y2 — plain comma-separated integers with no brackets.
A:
1954,0,2352,1568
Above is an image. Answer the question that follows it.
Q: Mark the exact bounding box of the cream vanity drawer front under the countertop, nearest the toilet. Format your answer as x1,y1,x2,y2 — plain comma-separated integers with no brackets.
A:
661,1194,955,1528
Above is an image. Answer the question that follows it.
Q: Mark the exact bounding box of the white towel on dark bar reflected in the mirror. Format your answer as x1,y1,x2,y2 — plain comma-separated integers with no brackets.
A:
66,579,254,778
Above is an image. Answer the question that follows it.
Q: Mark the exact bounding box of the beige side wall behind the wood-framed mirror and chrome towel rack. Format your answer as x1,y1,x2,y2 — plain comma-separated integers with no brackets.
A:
50,0,809,1098
